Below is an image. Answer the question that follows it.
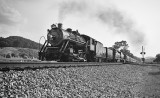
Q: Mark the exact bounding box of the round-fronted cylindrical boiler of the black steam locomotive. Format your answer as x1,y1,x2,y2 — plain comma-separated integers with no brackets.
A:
47,23,86,46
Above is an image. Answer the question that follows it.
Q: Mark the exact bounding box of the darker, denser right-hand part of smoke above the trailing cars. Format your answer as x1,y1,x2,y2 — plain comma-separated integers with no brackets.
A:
96,8,146,45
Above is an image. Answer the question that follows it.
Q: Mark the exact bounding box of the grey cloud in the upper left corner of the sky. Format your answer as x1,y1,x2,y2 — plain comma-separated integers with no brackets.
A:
0,0,22,25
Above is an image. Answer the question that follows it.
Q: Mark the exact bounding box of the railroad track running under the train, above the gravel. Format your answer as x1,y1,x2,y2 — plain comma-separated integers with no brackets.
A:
0,61,123,71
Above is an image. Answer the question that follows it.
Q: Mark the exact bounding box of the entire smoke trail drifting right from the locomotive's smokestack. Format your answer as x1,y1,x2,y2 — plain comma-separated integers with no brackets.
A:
59,0,146,46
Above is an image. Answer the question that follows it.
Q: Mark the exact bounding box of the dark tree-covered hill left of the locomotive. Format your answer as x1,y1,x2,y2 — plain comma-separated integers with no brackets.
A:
0,36,42,49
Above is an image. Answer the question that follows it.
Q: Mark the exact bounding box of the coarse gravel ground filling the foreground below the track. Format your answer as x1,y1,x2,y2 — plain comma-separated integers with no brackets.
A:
0,64,160,98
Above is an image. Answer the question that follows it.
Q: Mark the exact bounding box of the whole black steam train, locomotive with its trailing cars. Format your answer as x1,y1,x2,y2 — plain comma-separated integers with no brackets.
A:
39,23,135,62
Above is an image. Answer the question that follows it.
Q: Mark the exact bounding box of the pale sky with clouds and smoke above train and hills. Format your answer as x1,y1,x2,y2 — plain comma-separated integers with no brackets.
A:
0,0,160,57
